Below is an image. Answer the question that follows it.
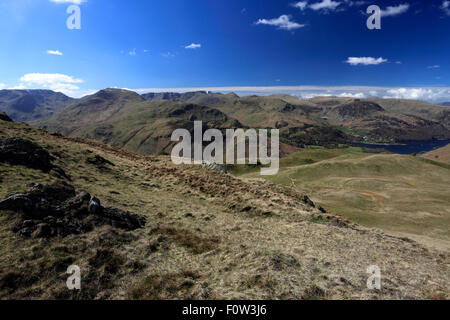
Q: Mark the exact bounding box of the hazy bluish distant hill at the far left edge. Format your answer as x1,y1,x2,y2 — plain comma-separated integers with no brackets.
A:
0,90,75,122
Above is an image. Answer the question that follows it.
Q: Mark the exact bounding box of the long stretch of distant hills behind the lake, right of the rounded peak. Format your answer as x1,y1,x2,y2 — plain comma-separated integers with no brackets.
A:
143,91,450,146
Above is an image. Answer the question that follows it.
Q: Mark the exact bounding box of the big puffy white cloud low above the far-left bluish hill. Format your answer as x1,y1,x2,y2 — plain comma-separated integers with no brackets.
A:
14,73,83,96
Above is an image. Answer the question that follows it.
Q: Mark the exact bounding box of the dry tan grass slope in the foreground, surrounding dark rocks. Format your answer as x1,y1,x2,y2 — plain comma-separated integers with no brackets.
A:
0,120,450,299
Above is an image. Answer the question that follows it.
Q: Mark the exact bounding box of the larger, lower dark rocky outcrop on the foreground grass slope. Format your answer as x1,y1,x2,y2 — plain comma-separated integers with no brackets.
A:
0,184,145,238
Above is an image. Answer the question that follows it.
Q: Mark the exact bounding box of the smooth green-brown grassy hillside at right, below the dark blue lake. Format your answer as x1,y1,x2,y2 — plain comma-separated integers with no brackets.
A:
241,149,450,250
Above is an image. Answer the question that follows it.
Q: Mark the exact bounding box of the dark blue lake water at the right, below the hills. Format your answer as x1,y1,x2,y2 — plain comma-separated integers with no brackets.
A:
356,140,450,154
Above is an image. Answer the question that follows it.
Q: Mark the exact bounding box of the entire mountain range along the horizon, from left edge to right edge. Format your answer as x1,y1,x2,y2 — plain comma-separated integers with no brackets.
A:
0,89,450,154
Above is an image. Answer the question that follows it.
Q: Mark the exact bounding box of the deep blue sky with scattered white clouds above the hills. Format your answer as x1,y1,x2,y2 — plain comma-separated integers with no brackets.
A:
0,0,450,101
